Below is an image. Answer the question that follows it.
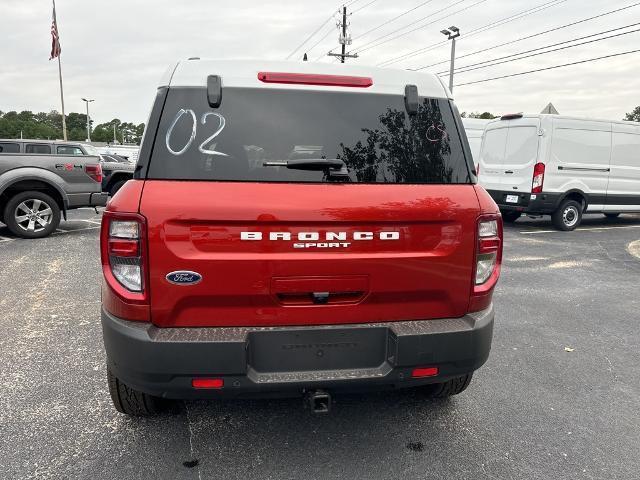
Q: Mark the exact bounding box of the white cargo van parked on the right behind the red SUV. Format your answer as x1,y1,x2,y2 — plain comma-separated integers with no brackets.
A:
479,114,640,230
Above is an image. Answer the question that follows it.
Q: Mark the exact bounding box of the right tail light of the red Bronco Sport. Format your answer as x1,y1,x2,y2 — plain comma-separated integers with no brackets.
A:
469,215,503,312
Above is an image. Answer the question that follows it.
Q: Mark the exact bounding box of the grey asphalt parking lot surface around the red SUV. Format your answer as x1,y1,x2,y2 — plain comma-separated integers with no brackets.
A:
0,210,640,479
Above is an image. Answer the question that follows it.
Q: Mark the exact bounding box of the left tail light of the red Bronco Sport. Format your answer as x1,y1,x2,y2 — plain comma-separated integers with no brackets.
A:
100,211,149,320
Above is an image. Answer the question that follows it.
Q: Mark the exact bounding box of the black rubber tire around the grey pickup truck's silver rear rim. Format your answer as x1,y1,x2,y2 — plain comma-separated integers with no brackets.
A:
3,190,60,238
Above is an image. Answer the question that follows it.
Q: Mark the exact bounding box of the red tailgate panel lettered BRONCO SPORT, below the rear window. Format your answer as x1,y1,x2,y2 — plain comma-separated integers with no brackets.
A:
140,180,479,327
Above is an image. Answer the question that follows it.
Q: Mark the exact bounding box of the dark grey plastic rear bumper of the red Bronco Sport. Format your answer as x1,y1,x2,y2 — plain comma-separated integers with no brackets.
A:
102,306,494,398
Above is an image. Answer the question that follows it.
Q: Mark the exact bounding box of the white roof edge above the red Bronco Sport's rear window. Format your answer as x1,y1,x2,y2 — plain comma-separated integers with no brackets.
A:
159,59,451,98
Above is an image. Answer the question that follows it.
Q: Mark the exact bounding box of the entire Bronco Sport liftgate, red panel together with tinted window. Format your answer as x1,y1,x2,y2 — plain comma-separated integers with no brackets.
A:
140,84,480,327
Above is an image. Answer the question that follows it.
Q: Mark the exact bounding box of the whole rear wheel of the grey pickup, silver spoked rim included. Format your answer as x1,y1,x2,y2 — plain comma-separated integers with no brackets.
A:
4,190,60,238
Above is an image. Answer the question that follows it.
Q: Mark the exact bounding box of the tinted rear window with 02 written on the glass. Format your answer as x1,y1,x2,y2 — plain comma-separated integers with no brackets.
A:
148,87,470,184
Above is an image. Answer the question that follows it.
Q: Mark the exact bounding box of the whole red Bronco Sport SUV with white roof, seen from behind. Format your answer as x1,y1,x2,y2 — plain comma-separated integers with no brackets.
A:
101,60,502,415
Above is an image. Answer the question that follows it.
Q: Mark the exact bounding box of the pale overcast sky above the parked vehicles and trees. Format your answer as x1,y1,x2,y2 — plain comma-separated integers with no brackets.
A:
0,0,640,123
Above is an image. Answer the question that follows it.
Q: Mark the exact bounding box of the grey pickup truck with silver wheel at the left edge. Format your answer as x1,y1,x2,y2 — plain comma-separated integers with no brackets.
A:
0,139,107,238
